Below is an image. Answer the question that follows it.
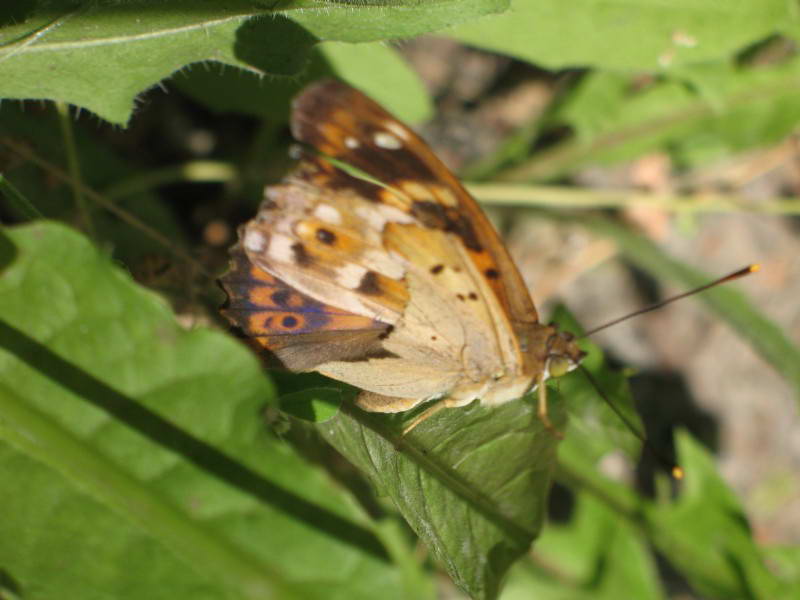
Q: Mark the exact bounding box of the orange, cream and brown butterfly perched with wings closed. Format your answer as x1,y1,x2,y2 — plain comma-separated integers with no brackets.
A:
220,80,584,431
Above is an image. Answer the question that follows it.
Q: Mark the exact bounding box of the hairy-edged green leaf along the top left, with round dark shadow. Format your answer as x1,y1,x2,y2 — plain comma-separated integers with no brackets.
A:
0,0,500,124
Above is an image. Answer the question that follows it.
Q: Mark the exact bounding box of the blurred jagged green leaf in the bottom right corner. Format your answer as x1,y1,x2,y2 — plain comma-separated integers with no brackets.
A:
556,424,800,599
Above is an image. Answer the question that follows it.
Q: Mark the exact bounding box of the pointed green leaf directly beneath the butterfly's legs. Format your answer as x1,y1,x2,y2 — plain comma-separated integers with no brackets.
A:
318,393,563,598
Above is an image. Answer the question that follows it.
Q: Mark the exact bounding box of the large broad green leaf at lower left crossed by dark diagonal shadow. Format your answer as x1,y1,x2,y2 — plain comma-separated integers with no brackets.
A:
0,222,418,599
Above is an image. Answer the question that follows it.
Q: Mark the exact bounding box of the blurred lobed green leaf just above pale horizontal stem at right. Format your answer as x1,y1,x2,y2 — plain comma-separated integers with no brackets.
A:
502,57,800,180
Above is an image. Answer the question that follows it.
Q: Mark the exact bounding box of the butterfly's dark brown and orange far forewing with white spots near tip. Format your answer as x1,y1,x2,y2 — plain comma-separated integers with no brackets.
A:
292,80,538,330
